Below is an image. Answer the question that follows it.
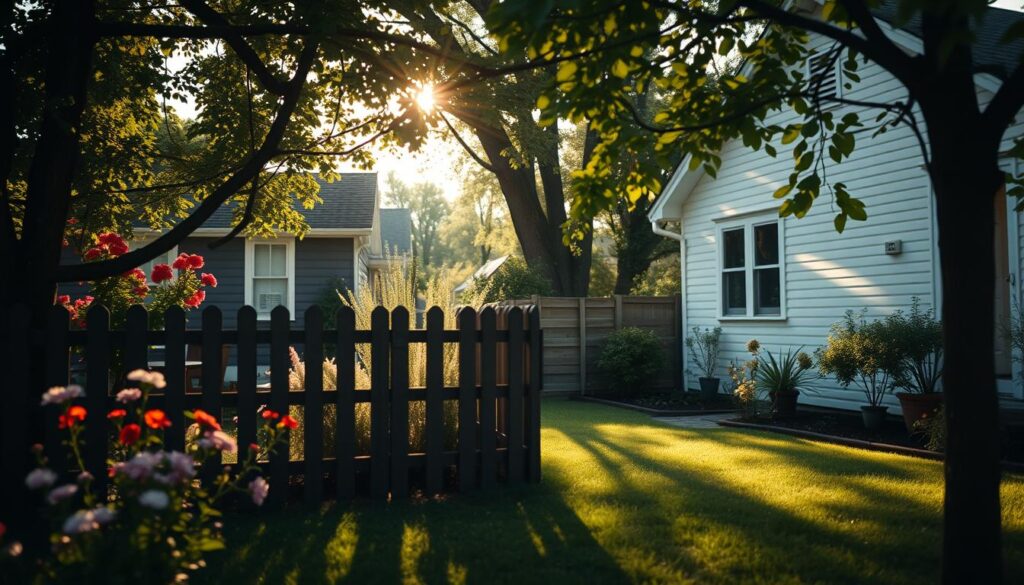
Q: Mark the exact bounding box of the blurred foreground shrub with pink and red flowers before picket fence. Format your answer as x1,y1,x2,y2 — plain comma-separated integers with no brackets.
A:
25,370,295,583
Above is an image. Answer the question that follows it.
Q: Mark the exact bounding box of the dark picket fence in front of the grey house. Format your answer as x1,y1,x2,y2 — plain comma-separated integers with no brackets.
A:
2,306,542,505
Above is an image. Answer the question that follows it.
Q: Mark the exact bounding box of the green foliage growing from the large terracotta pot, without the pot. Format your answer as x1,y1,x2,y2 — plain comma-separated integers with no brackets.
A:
885,297,942,394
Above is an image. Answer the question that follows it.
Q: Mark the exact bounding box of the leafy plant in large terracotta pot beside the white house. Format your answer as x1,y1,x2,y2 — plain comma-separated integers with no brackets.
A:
885,297,942,432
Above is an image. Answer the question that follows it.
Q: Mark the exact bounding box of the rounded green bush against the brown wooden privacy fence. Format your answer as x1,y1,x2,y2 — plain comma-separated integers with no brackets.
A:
597,327,665,394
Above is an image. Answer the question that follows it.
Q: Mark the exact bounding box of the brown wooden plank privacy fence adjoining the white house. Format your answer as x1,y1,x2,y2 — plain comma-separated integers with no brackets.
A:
504,295,683,394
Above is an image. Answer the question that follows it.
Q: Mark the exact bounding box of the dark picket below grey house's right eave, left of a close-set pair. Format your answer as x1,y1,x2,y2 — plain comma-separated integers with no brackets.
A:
370,306,388,500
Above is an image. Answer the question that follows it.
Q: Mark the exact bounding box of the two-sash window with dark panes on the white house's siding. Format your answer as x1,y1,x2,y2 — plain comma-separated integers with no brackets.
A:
718,217,785,319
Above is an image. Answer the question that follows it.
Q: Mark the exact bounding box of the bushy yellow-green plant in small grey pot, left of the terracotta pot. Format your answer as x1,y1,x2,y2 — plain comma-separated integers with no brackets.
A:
817,310,902,430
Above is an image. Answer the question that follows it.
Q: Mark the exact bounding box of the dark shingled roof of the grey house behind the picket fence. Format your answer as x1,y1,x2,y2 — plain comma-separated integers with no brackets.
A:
203,173,377,229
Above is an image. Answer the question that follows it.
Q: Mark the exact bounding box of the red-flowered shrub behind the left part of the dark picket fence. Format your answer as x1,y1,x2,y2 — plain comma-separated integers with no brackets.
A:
57,232,217,328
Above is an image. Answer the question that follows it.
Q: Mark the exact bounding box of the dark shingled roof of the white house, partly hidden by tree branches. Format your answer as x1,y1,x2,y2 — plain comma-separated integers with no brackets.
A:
871,2,1024,80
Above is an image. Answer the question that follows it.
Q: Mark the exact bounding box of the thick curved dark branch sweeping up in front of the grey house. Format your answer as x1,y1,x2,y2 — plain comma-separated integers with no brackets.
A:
56,42,317,282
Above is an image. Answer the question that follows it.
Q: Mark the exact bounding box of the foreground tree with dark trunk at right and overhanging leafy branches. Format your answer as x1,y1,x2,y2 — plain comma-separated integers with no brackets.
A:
490,0,1024,583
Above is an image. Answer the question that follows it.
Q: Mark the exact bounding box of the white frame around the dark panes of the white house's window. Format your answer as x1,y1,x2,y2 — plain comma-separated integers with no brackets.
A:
715,209,786,321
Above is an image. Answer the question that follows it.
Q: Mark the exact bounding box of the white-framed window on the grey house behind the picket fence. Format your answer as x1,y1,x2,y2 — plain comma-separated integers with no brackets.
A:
246,240,295,319
